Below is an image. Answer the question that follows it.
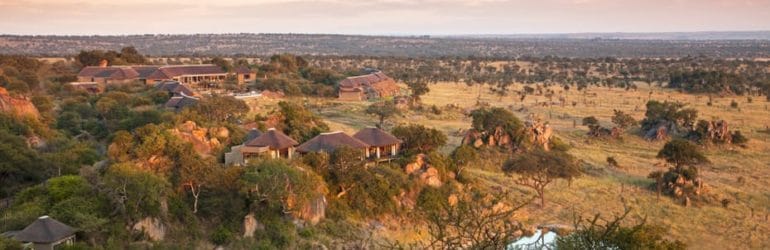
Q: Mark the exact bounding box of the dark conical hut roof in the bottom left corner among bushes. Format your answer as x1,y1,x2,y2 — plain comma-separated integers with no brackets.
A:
15,216,77,243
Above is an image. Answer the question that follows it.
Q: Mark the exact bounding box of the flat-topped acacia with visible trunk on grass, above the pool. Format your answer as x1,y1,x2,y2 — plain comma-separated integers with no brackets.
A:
503,150,580,208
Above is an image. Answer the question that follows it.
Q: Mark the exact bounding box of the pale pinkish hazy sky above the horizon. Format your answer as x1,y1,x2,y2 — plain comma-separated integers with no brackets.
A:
0,0,770,35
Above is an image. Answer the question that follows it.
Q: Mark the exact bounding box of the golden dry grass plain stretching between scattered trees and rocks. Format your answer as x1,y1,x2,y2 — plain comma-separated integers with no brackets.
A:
248,83,770,249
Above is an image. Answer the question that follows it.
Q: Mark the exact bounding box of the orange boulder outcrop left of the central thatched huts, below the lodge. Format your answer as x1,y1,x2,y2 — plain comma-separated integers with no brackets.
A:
171,121,230,155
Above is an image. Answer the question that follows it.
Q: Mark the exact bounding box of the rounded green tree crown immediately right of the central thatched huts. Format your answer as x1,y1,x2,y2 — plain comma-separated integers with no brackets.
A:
391,124,447,155
